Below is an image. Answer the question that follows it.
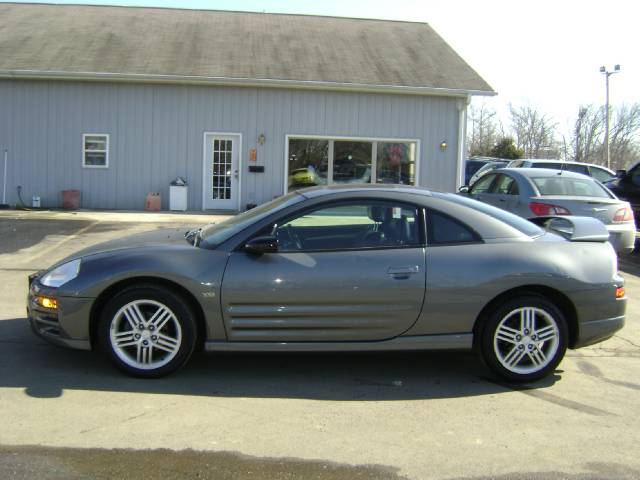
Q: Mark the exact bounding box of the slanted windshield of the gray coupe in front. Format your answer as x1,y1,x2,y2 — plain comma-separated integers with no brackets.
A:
200,192,304,247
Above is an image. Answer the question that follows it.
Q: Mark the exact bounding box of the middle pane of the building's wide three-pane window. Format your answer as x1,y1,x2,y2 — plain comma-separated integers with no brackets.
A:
333,140,373,183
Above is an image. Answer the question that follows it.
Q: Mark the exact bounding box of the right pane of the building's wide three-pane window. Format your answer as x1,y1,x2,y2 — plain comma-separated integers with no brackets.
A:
376,142,416,185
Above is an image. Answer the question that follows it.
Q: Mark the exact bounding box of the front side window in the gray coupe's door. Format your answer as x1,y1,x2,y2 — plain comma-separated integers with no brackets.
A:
275,201,421,252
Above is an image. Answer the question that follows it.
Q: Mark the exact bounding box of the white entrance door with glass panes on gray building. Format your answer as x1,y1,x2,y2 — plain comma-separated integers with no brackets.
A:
204,134,240,210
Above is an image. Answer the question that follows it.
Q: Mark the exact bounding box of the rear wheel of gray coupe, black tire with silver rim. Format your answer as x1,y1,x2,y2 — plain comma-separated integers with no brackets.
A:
478,295,569,383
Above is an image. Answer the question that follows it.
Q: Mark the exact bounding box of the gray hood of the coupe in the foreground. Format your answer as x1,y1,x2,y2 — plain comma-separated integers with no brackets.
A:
57,228,194,265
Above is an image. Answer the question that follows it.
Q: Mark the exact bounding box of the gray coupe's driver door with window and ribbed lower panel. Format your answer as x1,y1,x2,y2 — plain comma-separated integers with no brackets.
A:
222,200,425,342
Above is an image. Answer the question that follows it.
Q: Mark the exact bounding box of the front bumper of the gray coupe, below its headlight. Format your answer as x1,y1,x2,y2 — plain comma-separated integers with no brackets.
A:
27,274,91,350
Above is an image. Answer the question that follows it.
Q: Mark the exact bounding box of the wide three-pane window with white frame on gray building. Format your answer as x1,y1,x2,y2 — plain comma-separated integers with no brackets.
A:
287,136,417,190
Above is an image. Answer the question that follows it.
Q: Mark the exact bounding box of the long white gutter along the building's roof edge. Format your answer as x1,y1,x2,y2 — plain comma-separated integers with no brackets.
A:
0,70,496,97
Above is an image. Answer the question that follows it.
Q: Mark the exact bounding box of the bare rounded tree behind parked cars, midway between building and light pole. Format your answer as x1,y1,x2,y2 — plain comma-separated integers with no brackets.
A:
509,104,559,158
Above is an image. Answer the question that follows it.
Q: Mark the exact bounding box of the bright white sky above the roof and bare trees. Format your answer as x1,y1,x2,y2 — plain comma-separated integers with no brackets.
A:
12,0,640,130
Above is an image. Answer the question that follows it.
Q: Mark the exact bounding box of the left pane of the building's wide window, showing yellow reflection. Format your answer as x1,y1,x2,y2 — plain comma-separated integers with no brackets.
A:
288,139,329,190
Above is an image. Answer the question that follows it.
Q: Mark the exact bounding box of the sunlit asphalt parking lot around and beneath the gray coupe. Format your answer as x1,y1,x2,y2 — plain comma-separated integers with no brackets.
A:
0,212,640,479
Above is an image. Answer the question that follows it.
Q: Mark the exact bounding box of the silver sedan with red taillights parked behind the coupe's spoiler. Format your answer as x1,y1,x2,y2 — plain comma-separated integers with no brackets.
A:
465,168,636,254
